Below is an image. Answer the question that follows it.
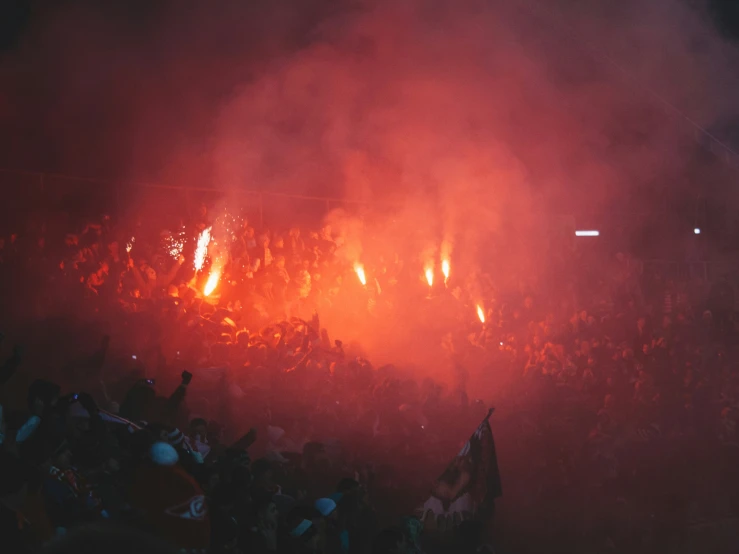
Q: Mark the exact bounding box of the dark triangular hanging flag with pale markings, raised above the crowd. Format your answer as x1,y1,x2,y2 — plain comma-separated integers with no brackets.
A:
422,409,503,523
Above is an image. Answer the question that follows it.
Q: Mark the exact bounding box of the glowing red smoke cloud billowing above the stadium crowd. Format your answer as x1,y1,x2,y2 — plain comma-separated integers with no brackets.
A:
0,0,739,251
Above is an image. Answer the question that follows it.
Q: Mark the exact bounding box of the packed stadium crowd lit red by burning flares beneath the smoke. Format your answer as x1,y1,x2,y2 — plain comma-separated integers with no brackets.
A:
0,204,739,553
